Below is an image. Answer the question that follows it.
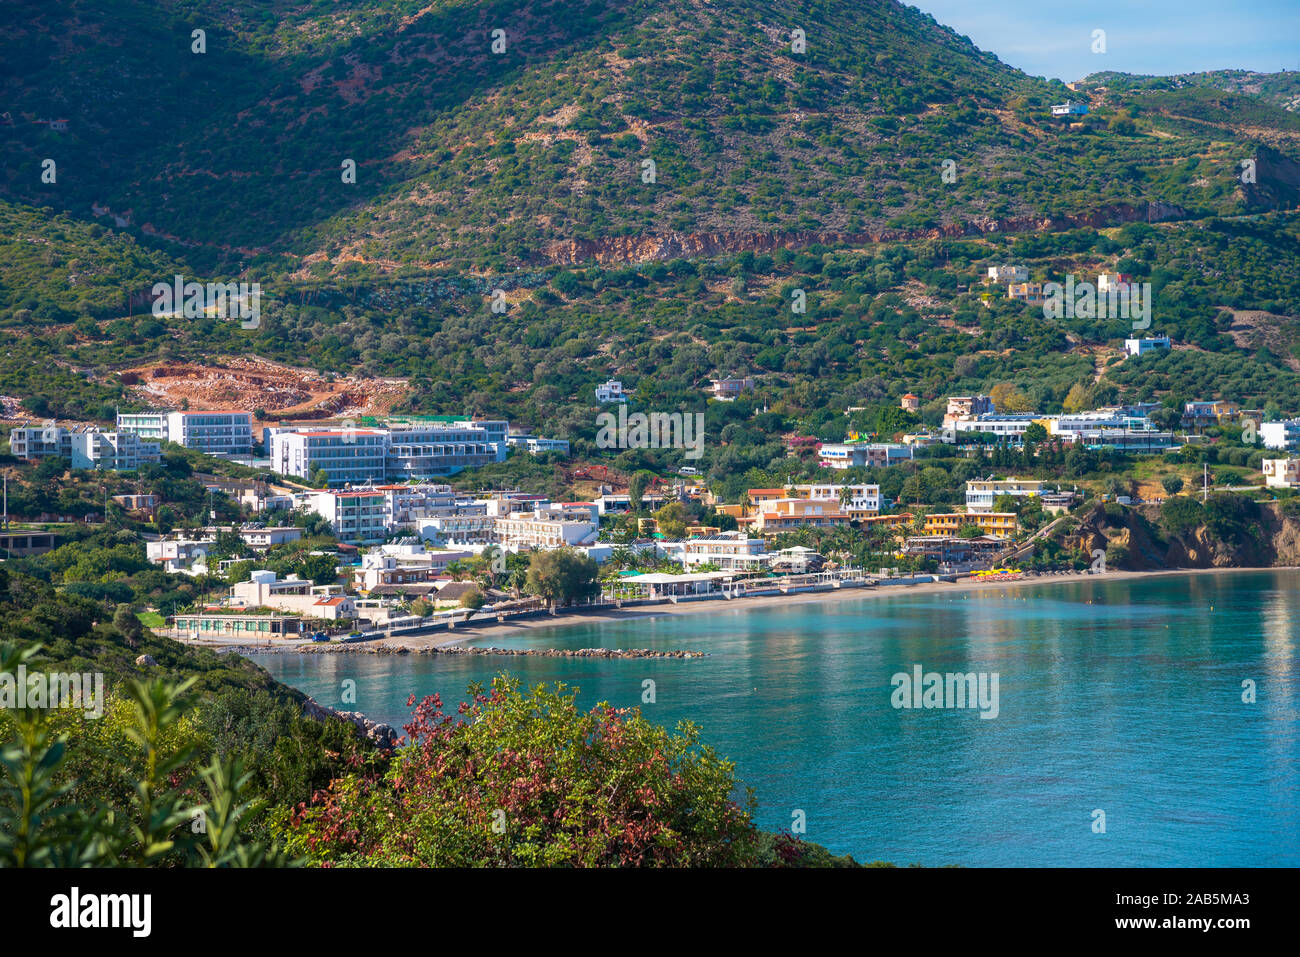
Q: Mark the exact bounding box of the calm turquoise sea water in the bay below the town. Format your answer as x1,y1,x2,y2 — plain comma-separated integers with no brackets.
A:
245,571,1300,866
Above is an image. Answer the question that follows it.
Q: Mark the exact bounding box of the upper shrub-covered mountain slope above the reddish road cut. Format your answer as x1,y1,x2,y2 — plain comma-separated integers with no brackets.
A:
0,0,1290,278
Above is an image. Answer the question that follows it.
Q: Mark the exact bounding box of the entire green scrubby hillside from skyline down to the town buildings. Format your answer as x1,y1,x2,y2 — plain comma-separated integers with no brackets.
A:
0,0,1300,481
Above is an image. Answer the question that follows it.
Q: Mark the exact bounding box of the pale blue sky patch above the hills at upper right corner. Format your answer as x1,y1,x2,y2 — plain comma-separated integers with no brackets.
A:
904,0,1300,82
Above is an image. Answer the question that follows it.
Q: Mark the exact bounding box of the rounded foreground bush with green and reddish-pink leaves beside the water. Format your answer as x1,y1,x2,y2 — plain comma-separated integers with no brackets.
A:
276,676,758,867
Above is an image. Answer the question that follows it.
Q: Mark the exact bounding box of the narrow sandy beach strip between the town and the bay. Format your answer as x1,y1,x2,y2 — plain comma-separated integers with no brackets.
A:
229,566,1279,654
